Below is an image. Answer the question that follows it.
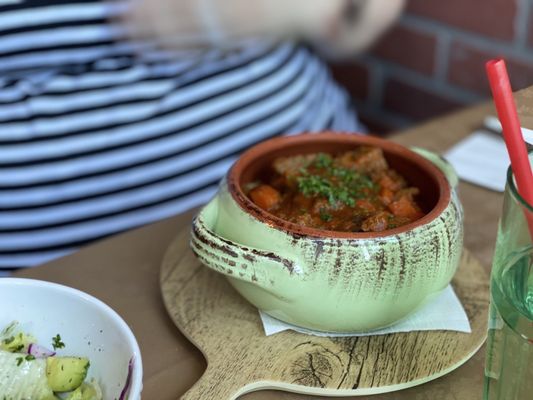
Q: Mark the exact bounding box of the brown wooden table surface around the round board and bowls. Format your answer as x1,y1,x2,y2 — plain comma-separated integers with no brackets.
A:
15,88,533,400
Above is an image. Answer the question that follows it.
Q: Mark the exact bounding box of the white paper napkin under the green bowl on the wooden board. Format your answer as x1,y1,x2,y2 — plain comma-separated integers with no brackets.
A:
259,285,472,337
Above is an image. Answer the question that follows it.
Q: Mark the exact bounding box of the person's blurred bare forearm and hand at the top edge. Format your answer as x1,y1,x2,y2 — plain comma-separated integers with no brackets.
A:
127,0,405,52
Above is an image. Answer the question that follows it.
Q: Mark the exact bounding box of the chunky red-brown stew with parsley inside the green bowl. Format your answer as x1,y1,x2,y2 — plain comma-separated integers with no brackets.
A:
245,146,424,232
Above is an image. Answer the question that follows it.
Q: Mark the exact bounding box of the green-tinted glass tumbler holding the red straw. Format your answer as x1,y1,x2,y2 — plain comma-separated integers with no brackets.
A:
484,158,533,400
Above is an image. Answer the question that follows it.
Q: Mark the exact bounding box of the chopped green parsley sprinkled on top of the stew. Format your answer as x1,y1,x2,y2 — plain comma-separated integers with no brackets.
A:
297,153,376,207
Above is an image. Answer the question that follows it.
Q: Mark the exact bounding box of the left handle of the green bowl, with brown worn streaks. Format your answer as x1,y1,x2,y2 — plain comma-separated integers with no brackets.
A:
191,209,300,292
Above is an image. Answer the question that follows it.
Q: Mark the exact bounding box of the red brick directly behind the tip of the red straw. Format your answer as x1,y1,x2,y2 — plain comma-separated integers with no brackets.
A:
448,41,533,95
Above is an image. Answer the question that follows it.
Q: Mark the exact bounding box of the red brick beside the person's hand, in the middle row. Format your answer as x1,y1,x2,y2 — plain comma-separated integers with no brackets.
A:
372,26,437,75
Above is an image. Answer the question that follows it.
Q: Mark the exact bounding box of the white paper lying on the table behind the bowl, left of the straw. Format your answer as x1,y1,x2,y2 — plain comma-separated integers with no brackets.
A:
444,130,510,192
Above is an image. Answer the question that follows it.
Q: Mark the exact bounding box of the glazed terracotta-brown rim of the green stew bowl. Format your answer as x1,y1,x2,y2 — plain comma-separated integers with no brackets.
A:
226,131,452,239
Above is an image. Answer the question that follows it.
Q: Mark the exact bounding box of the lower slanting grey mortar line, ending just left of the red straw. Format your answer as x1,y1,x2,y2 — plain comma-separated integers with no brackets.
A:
358,55,486,104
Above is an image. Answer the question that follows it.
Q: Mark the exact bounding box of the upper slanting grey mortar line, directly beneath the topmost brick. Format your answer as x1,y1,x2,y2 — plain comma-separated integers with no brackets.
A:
400,15,533,63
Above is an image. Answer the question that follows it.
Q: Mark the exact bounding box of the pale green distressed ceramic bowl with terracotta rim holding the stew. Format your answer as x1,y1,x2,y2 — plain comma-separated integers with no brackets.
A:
191,133,463,332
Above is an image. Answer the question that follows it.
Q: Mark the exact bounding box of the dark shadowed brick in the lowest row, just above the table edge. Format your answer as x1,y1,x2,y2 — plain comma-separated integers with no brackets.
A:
383,79,464,121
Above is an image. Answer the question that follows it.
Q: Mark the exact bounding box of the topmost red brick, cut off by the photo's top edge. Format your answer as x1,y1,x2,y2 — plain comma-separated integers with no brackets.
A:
407,0,518,40
